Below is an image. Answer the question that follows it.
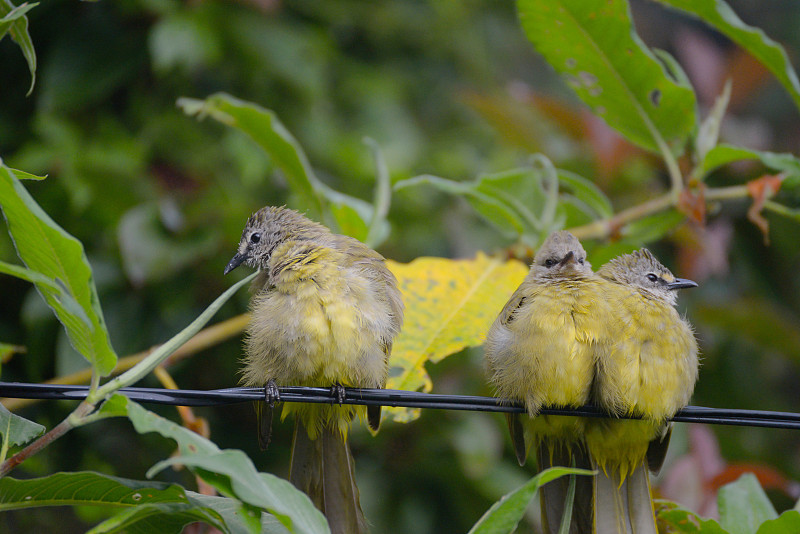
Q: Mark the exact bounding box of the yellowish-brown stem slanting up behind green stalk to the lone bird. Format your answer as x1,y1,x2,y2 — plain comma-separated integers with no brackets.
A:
2,313,250,412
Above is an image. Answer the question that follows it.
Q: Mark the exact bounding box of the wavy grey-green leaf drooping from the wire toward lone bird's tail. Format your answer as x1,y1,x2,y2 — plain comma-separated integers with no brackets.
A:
128,401,329,533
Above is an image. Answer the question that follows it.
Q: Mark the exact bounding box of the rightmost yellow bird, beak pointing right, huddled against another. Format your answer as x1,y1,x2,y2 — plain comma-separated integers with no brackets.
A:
585,249,698,534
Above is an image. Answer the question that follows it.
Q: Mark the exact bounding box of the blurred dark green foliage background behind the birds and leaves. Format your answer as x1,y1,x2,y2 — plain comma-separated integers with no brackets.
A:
0,0,800,533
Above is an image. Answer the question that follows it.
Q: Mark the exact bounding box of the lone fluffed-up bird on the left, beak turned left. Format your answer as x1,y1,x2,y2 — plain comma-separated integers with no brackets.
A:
225,207,403,534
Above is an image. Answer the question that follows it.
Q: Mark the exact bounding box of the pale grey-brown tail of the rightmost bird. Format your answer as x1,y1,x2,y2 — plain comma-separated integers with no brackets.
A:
594,461,658,534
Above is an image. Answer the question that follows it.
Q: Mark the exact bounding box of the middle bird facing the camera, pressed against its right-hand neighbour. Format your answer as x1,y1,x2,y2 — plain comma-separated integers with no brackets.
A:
484,230,615,533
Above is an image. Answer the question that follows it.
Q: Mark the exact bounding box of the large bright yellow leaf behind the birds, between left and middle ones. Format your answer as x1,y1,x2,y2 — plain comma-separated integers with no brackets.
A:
386,253,528,422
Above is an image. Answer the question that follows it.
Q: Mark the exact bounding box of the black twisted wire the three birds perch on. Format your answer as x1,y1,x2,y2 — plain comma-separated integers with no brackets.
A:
0,382,800,430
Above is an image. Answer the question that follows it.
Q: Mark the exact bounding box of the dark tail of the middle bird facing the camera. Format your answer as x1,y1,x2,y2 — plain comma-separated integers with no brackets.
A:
537,443,599,534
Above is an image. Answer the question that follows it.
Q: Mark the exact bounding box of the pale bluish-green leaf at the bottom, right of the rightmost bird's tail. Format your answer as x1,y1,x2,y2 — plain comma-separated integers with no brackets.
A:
717,473,778,534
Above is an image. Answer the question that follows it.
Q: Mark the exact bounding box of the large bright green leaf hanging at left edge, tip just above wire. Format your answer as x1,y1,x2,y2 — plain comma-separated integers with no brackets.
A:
0,163,117,376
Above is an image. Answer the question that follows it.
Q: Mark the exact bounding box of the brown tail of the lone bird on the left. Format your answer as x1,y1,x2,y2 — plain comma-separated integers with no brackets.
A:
289,421,367,534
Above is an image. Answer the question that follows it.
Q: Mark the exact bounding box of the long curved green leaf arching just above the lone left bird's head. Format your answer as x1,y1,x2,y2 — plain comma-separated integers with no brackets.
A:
178,93,382,241
